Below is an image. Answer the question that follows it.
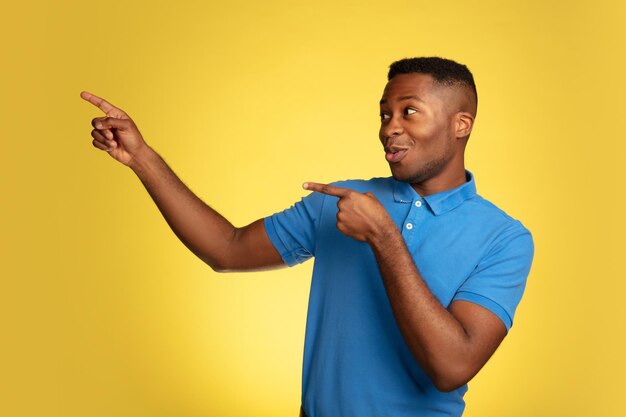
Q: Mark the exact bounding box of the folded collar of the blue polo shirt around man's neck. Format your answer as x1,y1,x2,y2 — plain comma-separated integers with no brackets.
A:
392,170,476,216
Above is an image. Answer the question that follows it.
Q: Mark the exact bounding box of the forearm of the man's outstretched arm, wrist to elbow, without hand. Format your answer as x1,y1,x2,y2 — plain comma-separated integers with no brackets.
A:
129,146,237,270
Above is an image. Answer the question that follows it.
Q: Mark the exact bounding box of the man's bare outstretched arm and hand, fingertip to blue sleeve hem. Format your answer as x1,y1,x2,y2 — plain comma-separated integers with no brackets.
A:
80,91,285,272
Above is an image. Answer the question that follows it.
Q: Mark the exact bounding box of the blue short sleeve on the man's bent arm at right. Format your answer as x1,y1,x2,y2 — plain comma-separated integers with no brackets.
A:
452,220,534,331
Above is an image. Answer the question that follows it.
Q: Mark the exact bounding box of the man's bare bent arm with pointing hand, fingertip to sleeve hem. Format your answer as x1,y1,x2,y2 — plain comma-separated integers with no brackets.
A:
304,182,506,391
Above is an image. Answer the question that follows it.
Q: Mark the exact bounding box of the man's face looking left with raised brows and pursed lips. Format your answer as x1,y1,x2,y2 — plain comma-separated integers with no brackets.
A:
379,73,462,184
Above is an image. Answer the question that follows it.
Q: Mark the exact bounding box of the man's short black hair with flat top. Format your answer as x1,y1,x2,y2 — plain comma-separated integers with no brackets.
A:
387,56,478,102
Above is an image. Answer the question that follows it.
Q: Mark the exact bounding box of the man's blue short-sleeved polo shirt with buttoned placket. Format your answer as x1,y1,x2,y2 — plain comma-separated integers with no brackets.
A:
264,171,534,417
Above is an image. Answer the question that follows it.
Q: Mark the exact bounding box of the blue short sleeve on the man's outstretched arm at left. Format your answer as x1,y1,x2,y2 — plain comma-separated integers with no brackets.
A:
263,193,325,266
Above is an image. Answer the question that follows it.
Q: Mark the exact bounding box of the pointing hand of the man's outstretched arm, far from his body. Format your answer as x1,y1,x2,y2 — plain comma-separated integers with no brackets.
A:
80,91,147,166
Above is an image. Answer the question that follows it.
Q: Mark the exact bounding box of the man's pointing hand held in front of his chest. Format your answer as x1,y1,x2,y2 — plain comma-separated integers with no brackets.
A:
302,182,397,243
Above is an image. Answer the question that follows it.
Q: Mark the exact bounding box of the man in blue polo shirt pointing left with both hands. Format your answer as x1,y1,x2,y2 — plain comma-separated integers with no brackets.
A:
81,57,533,417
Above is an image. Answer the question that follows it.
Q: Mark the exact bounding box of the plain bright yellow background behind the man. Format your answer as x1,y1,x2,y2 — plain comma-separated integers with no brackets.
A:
0,0,626,417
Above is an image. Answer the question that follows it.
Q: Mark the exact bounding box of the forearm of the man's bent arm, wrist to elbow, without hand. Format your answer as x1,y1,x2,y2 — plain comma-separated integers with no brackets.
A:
370,229,473,391
